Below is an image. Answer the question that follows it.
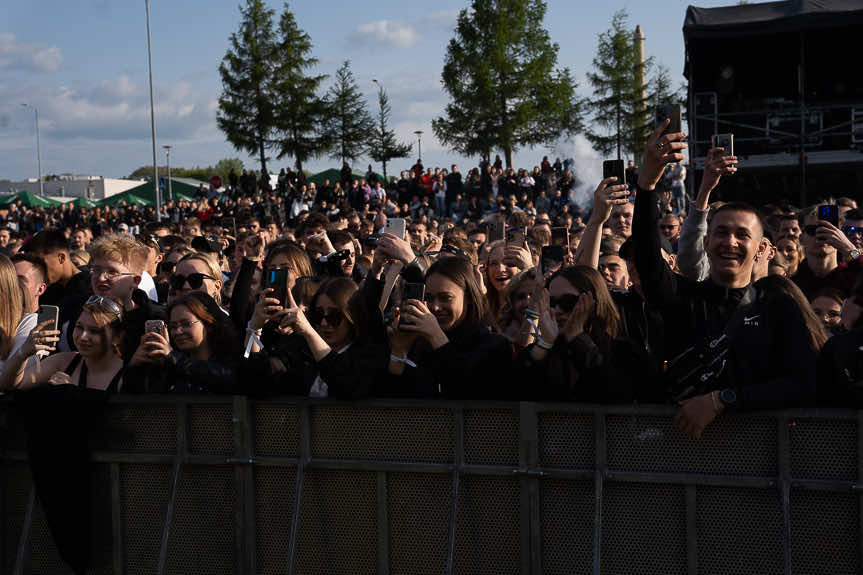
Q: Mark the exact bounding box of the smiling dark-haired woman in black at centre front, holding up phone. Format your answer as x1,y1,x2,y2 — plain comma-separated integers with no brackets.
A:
378,258,513,399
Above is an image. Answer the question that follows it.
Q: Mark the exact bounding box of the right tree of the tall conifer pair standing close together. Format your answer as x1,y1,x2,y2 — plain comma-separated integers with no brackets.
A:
273,3,327,171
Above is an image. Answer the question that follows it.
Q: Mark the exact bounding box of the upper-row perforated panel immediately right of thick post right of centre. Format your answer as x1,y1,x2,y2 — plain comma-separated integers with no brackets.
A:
538,413,596,469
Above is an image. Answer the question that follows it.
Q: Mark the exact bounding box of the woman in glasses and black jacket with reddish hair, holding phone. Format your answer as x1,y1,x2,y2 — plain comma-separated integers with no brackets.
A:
126,292,240,393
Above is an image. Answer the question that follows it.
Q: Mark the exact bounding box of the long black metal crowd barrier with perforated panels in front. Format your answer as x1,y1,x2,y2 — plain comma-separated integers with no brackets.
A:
0,396,863,575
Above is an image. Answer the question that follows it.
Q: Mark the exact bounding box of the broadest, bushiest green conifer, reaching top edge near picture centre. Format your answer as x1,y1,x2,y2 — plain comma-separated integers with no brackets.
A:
432,0,581,167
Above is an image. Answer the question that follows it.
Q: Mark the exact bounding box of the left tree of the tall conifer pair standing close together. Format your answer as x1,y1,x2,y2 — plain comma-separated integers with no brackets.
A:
216,0,275,176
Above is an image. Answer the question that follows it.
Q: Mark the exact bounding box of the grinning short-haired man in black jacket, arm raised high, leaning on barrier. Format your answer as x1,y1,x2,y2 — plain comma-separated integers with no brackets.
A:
633,122,815,437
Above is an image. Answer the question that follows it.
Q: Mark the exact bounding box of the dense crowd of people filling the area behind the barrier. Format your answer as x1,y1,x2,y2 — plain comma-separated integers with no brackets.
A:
0,120,863,437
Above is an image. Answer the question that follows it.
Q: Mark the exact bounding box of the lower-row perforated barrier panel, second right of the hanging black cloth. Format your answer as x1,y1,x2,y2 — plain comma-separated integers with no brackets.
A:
168,465,237,575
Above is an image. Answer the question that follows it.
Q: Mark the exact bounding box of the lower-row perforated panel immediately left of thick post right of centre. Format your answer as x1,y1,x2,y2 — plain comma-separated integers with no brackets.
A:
453,476,521,575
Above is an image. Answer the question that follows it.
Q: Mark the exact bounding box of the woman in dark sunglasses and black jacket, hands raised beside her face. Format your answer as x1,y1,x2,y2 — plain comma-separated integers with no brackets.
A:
518,266,654,403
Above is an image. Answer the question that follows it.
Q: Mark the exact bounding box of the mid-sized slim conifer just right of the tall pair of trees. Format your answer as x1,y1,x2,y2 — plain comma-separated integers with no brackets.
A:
324,60,373,163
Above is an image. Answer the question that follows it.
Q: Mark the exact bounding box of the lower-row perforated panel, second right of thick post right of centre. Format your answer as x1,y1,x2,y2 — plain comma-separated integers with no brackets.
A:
602,482,684,575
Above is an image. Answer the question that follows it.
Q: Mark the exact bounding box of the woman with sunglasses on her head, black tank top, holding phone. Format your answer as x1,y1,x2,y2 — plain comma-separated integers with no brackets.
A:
2,295,124,393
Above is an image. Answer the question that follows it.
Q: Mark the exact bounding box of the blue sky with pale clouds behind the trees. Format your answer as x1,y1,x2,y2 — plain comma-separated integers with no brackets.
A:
0,0,734,180
